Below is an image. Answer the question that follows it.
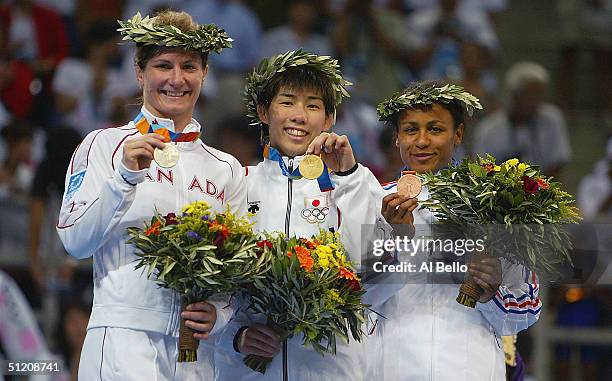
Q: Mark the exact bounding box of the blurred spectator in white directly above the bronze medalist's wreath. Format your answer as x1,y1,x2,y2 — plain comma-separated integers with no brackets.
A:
406,0,499,81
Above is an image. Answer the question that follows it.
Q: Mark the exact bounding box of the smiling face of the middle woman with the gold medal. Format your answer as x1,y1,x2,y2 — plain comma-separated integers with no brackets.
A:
258,86,333,156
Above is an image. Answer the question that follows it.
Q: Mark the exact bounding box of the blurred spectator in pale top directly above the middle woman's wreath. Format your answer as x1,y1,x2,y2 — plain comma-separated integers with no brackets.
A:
260,0,332,57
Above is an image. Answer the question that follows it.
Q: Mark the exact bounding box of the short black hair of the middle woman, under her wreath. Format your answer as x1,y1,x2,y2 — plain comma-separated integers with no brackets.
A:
257,65,336,115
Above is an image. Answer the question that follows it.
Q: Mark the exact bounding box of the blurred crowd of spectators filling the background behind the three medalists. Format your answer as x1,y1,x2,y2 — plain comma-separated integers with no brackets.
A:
0,0,612,380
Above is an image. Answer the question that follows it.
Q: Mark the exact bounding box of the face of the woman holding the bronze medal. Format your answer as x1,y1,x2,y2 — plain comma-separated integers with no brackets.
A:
395,103,464,173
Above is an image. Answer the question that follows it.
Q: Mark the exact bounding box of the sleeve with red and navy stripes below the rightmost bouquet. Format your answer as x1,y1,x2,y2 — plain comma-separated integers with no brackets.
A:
476,258,542,336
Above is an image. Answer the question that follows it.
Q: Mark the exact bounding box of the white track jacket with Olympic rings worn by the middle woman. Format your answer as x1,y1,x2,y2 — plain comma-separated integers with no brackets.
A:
215,157,383,381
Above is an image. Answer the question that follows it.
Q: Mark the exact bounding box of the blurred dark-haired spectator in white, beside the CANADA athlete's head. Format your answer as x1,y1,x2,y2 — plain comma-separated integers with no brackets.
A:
53,21,125,137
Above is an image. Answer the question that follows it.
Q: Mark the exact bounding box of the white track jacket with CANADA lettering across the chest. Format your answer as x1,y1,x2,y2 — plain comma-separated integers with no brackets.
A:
57,107,246,356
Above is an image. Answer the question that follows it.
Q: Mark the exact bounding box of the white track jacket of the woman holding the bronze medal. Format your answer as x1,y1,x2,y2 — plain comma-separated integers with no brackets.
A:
366,183,542,381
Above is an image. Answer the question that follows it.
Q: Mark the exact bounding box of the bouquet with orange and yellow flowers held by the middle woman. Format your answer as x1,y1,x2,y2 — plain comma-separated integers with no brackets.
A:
244,230,367,374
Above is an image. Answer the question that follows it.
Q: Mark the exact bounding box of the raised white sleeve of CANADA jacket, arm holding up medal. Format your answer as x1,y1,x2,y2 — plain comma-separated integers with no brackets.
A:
57,130,147,259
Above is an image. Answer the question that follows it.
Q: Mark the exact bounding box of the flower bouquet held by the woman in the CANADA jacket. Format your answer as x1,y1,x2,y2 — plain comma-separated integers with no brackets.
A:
128,201,270,362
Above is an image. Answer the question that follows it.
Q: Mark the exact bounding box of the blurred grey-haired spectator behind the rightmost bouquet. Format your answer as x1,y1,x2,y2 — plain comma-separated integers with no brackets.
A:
472,62,572,176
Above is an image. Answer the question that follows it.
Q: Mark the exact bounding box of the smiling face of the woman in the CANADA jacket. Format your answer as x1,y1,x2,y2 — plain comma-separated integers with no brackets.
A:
136,49,208,132
